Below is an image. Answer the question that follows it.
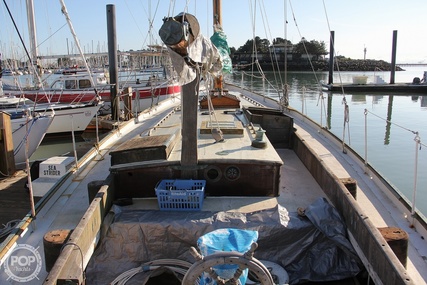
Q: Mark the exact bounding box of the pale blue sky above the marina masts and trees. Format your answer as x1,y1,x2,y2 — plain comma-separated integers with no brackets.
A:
0,0,427,64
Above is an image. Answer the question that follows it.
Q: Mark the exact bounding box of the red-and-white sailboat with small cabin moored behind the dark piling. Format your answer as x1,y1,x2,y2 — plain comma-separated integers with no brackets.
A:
4,0,180,116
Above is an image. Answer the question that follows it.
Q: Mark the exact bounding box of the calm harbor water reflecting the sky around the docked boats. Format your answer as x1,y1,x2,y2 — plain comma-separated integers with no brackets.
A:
31,65,427,215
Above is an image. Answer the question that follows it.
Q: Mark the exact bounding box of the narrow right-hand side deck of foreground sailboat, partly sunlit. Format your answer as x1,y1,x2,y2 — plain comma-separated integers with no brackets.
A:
290,116,427,284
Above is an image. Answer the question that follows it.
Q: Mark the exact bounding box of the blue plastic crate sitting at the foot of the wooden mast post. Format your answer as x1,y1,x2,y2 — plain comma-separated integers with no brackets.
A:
155,179,206,211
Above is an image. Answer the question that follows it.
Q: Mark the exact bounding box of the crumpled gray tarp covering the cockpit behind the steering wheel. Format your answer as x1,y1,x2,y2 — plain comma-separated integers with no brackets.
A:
87,199,362,284
